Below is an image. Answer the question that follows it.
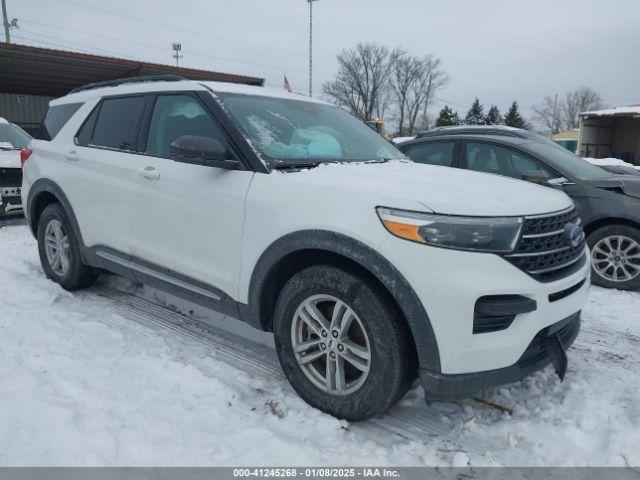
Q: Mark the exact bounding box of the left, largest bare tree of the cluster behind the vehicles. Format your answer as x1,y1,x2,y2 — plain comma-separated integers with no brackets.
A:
322,43,401,120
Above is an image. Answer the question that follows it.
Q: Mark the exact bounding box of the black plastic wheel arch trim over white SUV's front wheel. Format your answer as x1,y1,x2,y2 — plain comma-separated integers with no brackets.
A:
241,230,440,371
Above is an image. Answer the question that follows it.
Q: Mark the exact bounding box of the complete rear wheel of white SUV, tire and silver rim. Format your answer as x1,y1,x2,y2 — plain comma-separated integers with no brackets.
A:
38,203,97,291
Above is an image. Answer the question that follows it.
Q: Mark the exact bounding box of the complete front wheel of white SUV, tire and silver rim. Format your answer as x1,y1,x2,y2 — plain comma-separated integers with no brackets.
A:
274,265,417,421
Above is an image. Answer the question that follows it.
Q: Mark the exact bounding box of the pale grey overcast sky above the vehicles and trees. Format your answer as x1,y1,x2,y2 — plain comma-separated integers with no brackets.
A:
7,0,640,120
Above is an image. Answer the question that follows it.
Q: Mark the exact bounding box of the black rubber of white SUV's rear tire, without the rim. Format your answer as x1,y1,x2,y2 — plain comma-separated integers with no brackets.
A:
38,203,97,291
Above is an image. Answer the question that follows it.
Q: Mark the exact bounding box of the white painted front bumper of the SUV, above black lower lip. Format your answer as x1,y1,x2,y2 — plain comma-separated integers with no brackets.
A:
378,238,590,376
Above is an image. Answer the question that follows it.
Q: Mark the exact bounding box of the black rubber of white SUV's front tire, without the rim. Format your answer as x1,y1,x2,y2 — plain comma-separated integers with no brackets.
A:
274,265,417,421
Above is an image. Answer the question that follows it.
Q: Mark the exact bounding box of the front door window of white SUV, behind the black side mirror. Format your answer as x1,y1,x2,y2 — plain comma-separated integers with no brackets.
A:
146,95,229,157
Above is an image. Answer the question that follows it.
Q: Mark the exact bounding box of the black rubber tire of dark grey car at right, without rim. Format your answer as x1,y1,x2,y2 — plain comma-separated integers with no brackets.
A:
587,224,640,290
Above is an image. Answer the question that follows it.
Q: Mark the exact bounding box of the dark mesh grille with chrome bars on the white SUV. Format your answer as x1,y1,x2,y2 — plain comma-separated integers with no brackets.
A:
505,207,585,280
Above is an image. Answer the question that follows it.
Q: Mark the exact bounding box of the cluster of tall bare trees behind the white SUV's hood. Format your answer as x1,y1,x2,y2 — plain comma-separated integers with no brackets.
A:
322,43,449,136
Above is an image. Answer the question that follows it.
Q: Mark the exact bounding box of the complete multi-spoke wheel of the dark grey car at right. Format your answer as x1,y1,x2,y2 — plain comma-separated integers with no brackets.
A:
587,225,640,290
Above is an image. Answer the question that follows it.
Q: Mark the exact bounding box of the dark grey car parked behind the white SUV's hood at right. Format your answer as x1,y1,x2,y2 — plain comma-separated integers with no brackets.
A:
398,126,640,290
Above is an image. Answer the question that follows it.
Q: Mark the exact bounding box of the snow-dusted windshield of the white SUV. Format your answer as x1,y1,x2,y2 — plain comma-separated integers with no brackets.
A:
220,94,406,167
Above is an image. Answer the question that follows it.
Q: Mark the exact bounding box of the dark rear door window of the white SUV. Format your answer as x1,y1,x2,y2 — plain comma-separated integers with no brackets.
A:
76,97,145,151
